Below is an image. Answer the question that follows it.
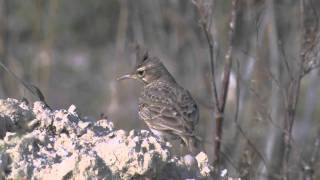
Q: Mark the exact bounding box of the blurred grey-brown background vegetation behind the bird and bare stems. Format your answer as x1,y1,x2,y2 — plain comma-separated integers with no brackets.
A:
0,0,320,179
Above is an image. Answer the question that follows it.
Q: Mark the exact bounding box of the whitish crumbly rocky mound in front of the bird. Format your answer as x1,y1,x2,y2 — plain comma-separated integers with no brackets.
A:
0,99,212,180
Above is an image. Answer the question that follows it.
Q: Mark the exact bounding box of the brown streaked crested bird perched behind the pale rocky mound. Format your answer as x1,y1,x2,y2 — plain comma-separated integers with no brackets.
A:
117,45,200,154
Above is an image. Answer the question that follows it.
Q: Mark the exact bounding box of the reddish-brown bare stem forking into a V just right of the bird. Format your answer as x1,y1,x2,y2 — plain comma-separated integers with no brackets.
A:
192,0,238,169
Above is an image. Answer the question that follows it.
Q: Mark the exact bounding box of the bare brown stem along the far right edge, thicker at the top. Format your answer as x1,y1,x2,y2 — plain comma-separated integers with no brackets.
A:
282,0,319,180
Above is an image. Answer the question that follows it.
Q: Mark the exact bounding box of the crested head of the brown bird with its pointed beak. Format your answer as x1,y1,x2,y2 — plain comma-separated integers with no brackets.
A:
118,46,173,84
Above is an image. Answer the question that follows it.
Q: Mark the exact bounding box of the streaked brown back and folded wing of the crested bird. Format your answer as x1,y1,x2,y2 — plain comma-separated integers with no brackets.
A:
139,83,198,135
